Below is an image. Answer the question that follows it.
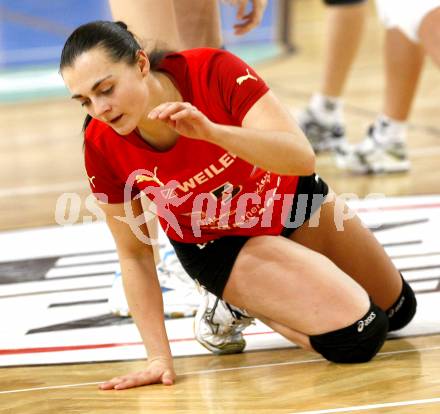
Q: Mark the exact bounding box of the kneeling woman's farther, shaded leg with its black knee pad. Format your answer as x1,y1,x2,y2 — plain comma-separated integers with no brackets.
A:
290,188,416,330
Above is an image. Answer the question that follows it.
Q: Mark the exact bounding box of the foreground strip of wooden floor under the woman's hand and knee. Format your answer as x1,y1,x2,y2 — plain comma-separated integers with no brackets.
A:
0,336,440,414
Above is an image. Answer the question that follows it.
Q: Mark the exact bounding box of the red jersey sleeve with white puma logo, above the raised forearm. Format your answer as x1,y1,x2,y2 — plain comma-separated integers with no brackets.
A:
211,51,269,124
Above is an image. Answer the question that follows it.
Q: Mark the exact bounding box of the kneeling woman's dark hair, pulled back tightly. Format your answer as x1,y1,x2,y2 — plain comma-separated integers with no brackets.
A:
60,20,169,138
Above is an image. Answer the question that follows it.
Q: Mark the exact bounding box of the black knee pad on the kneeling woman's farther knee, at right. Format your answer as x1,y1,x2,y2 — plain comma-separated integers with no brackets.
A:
386,277,417,331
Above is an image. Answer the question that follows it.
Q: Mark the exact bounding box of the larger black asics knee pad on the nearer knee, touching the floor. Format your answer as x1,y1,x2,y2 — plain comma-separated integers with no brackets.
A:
310,302,388,364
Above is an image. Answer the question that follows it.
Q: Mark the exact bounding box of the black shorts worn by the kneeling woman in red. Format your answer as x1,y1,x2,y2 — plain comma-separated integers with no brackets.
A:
170,174,328,298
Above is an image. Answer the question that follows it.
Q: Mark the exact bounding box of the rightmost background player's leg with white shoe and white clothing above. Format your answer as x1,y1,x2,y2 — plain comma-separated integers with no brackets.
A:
346,0,440,173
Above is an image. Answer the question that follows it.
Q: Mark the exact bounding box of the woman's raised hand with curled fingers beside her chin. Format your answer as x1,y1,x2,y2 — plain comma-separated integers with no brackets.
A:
148,102,215,140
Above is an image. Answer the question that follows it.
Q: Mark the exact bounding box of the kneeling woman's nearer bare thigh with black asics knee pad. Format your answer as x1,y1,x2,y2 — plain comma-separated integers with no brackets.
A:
223,236,388,362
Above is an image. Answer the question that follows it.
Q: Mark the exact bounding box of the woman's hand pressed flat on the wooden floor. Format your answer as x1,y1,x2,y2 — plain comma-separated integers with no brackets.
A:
99,358,176,390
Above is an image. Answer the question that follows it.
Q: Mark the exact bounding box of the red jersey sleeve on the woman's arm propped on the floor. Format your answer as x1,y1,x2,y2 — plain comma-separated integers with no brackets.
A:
84,141,125,204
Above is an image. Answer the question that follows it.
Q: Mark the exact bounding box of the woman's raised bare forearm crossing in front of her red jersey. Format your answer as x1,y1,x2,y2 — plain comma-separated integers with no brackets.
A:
207,124,315,175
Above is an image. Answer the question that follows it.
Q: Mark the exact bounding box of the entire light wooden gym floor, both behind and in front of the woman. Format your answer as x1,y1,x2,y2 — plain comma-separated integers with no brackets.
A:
0,0,440,414
